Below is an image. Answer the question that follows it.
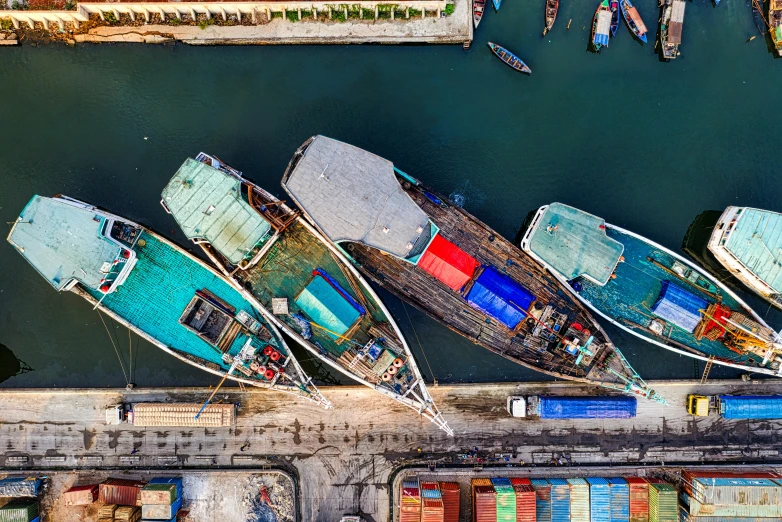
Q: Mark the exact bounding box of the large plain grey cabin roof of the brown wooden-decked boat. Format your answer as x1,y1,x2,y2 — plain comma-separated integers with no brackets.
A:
283,136,429,257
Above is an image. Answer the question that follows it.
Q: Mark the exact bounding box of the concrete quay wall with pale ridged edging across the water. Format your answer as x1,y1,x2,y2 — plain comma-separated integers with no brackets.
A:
0,0,473,45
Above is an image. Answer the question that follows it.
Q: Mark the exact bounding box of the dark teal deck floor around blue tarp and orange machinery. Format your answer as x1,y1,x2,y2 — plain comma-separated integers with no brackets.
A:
579,227,761,363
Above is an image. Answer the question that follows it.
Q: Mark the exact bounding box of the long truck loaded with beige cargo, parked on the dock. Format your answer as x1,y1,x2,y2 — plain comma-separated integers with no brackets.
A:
106,402,236,428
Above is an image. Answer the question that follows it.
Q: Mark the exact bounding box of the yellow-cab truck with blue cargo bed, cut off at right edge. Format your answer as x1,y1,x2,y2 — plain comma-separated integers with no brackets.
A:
687,395,782,419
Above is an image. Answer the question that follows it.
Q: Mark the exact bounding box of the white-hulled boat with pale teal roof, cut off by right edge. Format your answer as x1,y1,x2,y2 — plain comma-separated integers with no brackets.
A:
708,207,782,308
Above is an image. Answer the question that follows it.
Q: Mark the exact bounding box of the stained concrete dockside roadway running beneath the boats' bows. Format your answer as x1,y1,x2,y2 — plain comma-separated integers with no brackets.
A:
0,380,782,521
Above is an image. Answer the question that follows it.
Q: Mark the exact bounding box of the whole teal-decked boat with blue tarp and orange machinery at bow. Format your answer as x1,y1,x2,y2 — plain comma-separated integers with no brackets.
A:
521,203,782,375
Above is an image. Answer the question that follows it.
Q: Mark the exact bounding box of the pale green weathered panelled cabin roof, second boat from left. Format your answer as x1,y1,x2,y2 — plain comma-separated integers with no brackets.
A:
163,158,271,265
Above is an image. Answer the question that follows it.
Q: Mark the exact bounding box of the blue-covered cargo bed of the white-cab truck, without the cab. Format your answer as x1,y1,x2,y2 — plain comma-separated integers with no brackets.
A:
540,395,637,419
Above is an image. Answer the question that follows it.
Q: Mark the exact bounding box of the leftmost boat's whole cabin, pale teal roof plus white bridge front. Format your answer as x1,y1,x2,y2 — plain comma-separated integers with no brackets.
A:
8,196,143,294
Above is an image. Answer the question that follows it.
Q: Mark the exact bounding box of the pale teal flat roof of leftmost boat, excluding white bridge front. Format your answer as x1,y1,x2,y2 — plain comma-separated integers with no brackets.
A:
8,196,120,290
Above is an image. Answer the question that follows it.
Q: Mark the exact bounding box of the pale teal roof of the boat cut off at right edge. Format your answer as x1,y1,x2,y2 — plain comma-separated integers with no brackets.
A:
725,208,782,292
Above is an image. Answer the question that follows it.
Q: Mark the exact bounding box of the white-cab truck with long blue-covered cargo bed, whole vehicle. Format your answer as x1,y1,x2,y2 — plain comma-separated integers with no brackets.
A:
506,395,637,419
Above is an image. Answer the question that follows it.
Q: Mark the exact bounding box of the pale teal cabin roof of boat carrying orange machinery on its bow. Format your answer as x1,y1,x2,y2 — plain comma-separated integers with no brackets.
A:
529,203,624,285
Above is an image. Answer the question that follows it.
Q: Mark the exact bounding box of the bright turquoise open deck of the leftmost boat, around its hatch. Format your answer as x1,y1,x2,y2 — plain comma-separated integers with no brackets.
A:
88,231,287,370
